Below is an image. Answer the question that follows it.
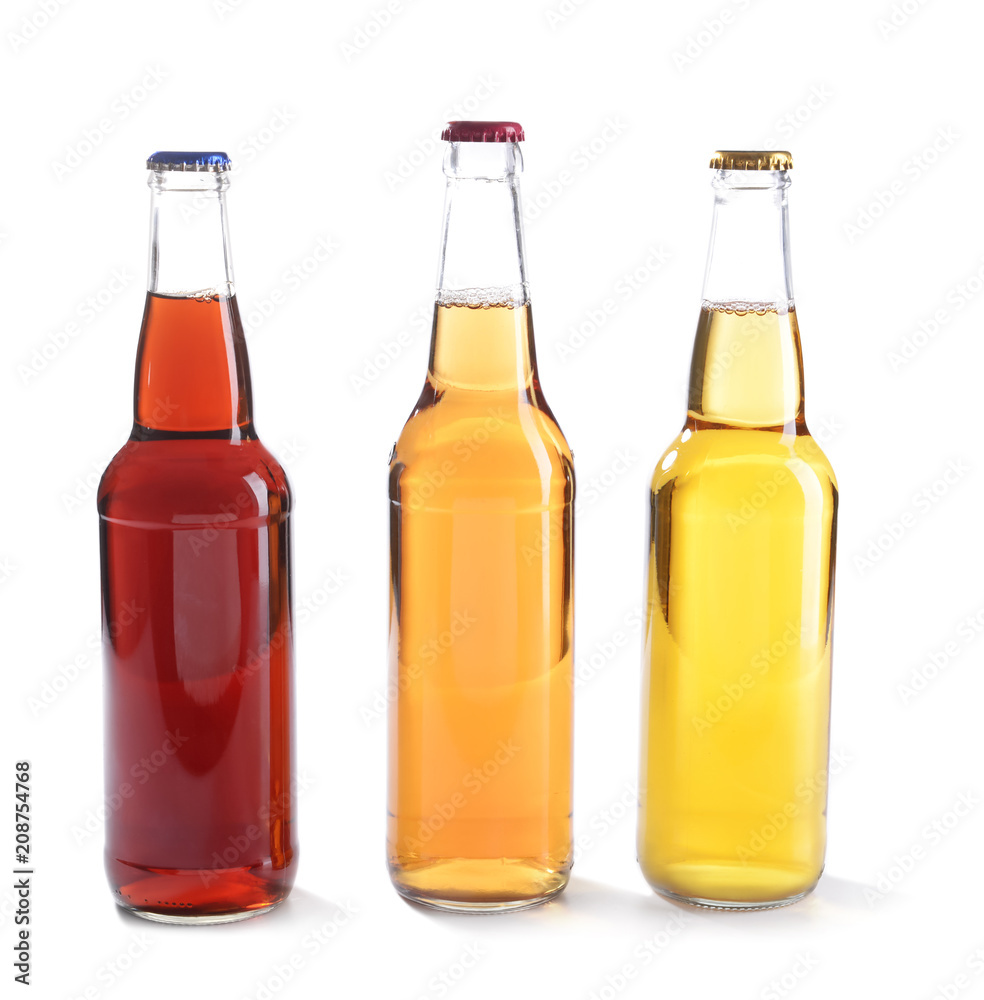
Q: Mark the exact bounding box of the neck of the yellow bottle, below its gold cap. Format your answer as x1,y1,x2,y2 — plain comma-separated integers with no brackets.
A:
688,170,803,428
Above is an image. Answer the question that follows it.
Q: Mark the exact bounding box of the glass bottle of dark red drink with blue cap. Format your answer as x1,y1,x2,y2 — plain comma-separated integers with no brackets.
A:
98,152,297,923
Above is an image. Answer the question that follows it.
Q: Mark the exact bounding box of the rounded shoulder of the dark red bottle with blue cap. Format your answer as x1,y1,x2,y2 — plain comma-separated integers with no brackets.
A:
97,437,292,525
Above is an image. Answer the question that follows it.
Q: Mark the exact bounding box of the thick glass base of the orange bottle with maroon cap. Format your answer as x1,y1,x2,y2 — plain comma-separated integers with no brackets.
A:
390,858,569,913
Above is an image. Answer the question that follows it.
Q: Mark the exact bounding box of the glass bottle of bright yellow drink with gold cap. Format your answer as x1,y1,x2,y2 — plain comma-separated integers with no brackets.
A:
638,151,837,909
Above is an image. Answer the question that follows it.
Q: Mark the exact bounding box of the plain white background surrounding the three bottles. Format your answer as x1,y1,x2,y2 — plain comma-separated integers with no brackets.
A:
0,0,984,1000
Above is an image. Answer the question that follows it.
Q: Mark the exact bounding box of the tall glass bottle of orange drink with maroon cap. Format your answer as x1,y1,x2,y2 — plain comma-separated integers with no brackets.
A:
387,122,574,910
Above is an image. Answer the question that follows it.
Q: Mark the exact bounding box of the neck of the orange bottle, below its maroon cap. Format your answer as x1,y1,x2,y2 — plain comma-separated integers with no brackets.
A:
430,142,536,390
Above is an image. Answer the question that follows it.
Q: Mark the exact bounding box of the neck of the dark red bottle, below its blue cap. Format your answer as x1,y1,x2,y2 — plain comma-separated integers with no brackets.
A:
133,170,253,439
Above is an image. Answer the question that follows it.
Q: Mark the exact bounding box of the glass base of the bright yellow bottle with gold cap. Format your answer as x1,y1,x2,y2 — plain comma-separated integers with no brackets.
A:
644,864,820,910
